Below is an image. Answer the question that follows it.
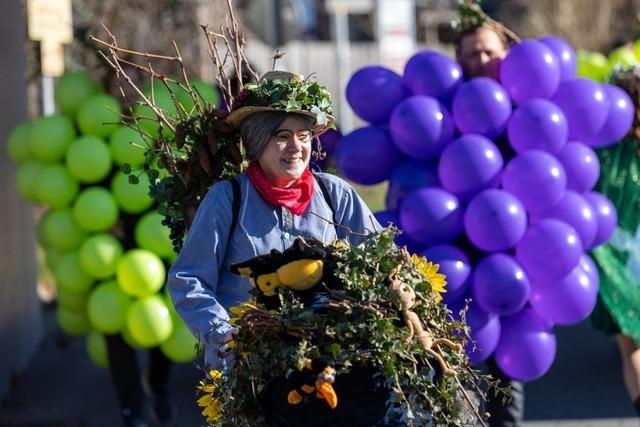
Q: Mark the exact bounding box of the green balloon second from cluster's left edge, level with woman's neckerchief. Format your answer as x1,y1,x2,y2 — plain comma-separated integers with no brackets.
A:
36,163,80,209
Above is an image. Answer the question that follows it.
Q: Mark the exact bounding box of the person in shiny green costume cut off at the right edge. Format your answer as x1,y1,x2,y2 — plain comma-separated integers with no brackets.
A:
591,66,640,416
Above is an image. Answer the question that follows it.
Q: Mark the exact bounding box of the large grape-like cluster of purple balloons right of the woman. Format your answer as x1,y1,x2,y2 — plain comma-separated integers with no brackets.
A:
335,37,634,381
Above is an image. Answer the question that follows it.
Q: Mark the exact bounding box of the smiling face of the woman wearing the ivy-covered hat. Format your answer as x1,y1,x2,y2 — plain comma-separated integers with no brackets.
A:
258,116,313,187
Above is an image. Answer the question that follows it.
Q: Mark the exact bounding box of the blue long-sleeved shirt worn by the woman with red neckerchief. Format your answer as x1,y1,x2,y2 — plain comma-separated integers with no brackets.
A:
169,174,381,367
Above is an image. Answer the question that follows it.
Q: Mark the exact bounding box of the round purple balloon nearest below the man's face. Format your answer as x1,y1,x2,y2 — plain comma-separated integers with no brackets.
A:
452,77,511,139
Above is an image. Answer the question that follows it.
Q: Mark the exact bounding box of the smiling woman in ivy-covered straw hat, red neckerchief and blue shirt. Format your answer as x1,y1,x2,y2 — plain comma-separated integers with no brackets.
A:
169,72,387,426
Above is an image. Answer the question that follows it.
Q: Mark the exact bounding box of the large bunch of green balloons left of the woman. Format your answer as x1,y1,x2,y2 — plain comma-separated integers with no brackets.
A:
6,73,198,367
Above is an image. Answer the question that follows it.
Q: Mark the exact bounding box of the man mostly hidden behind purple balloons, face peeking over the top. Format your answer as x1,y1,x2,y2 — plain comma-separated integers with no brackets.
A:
456,23,524,427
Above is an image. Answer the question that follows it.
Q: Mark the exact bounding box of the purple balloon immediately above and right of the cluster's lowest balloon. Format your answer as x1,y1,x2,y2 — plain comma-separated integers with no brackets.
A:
529,264,598,325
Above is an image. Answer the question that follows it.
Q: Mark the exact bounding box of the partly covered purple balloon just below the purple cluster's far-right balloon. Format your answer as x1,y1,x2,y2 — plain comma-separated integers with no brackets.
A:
556,142,600,193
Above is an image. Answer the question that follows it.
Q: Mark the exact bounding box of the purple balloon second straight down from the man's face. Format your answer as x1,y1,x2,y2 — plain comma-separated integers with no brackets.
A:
438,134,504,201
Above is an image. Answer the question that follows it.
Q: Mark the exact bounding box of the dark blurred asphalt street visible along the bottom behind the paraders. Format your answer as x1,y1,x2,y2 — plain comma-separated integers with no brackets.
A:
0,307,640,427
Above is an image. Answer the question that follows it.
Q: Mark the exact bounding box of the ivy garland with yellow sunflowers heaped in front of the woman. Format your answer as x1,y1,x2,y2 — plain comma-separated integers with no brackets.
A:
198,229,494,427
